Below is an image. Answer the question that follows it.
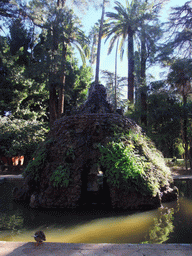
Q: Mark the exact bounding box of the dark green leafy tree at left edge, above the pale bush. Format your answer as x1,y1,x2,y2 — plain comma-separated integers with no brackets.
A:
0,29,47,120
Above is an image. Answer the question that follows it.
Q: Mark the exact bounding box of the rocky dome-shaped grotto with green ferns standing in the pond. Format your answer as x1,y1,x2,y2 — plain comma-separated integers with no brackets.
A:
14,84,178,209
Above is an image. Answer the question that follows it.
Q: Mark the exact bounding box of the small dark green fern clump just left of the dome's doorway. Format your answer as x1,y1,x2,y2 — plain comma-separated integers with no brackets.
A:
50,165,70,187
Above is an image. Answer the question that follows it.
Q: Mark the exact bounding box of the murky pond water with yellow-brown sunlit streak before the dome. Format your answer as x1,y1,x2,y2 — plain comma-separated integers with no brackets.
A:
0,179,192,243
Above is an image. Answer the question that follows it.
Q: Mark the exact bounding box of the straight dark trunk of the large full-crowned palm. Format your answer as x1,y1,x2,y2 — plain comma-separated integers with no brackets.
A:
128,31,134,104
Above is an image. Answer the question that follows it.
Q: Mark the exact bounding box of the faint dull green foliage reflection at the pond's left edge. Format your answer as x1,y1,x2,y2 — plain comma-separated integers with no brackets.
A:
0,211,23,231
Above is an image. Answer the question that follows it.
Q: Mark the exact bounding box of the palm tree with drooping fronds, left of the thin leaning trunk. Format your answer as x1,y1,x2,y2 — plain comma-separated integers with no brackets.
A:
50,9,88,124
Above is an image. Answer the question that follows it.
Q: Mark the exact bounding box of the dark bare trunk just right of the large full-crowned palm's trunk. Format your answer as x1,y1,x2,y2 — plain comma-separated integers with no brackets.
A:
141,31,147,126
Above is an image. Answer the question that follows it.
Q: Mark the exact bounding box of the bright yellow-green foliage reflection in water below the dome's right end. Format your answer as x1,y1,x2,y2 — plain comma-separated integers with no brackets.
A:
144,207,174,244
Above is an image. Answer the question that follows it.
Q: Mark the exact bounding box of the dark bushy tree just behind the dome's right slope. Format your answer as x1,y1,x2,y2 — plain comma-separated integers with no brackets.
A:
146,81,182,157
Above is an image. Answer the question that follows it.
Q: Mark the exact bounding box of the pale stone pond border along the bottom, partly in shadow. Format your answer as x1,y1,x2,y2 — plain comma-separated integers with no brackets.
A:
0,242,192,256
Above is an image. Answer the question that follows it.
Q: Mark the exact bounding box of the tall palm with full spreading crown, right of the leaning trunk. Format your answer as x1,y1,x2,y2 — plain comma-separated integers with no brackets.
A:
105,0,158,103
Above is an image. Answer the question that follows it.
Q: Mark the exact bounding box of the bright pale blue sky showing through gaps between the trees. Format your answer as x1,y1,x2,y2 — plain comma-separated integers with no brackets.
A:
68,0,187,89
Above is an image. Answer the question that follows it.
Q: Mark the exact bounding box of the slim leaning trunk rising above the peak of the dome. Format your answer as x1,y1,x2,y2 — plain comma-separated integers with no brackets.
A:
95,0,105,84
